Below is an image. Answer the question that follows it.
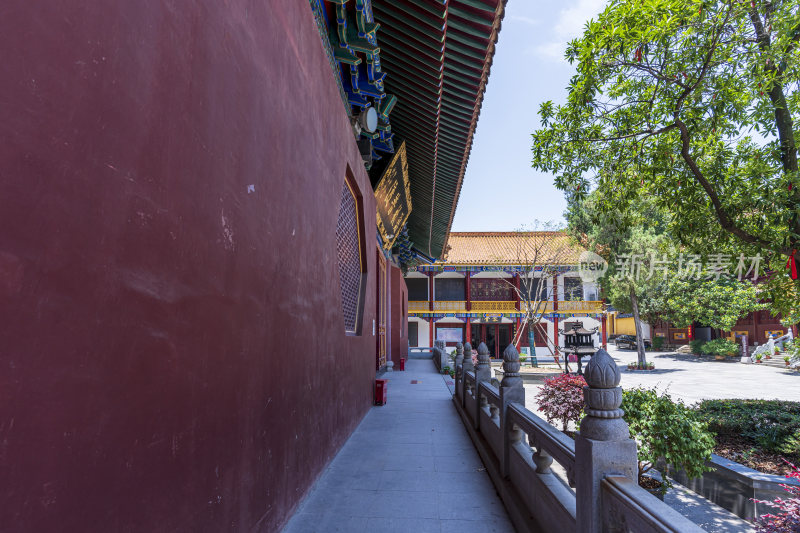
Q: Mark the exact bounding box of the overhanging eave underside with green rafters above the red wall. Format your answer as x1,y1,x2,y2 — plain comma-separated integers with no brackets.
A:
372,0,507,259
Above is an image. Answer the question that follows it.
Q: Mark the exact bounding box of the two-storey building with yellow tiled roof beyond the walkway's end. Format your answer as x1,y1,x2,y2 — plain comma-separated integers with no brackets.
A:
405,232,606,358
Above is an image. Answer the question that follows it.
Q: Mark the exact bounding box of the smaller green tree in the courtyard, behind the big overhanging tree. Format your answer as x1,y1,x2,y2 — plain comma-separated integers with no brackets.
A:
566,192,766,358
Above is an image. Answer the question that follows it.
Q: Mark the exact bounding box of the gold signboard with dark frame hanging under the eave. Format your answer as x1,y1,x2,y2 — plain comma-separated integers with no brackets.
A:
375,141,411,250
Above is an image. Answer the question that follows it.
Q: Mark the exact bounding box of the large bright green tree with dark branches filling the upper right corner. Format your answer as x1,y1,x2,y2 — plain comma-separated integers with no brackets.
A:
533,0,800,313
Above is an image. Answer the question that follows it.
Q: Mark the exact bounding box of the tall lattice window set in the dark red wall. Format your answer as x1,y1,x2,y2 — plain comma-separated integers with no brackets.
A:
336,175,366,335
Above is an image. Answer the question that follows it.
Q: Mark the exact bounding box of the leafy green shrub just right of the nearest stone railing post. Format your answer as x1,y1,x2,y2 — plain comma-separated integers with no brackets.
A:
621,389,714,500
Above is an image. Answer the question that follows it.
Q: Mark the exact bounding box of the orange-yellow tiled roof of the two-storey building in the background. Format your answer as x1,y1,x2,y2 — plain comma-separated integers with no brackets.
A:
444,231,584,265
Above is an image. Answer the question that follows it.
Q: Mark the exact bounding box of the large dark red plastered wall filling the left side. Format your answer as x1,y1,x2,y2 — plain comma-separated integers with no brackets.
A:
0,0,375,532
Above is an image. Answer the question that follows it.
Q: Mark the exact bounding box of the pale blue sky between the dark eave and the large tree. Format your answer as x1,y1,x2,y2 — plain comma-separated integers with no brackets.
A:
452,0,605,231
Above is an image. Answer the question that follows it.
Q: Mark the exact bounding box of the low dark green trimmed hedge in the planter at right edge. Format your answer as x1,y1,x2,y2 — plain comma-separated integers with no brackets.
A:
697,399,800,456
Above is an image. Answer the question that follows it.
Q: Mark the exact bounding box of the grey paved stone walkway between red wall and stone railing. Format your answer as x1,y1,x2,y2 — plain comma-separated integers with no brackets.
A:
284,360,514,533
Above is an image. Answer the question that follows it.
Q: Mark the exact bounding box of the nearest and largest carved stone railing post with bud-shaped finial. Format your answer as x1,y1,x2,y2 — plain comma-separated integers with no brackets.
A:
575,349,638,533
